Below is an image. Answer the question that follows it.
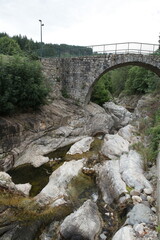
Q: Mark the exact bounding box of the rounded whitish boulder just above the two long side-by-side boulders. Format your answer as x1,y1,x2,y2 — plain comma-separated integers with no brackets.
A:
101,134,129,159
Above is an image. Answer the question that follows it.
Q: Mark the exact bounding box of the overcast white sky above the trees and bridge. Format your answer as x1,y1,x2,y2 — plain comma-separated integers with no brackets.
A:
0,0,160,46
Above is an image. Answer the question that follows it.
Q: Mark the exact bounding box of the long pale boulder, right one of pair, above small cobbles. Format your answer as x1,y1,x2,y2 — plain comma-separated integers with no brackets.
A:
120,150,153,192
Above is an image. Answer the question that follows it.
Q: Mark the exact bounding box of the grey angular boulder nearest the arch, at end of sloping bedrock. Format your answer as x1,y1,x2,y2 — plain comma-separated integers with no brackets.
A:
103,102,132,129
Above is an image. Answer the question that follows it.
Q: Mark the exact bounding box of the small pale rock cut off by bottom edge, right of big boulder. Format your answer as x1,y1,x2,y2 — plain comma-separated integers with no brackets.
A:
112,226,136,240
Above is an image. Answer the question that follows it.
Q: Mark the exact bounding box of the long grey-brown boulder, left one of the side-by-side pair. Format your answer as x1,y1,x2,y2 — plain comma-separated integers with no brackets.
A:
95,160,127,204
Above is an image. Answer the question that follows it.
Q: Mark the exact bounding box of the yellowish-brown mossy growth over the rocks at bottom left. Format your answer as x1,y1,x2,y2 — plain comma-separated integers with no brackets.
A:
0,190,71,224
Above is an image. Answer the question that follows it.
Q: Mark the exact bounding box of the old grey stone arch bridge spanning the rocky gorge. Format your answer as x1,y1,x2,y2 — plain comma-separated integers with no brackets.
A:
41,43,160,105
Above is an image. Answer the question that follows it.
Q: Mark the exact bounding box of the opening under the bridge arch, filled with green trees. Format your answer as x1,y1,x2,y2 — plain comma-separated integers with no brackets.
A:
86,62,160,105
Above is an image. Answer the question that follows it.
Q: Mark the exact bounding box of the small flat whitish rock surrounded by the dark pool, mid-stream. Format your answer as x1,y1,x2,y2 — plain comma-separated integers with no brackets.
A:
67,137,94,155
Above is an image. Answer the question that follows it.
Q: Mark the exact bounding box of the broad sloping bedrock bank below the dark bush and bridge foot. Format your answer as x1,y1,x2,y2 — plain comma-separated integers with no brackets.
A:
0,100,113,171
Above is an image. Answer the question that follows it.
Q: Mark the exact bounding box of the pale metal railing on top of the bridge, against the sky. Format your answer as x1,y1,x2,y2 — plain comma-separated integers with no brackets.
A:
87,42,160,55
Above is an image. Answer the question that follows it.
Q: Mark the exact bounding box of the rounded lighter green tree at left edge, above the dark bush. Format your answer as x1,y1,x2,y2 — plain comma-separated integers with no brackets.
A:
0,36,22,55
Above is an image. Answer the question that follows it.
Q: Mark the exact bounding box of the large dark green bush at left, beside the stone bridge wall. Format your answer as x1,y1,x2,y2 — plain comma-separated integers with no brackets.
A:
0,56,47,114
